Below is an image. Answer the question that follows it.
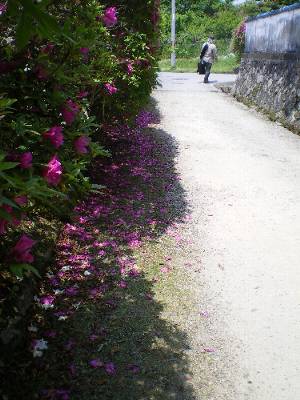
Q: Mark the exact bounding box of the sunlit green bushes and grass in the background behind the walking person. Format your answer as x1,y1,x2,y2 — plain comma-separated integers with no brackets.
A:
159,0,295,73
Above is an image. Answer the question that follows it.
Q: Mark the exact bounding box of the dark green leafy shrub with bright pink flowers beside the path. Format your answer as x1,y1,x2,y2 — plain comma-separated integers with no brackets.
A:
0,0,159,280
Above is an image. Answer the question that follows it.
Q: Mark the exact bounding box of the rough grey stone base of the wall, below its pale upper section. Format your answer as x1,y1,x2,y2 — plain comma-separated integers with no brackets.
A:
232,53,300,133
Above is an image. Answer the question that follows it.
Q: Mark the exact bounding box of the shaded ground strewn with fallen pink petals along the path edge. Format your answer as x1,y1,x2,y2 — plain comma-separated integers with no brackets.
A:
2,100,195,400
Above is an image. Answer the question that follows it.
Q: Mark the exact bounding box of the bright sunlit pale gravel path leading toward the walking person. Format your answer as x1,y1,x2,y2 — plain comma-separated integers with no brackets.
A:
154,73,300,400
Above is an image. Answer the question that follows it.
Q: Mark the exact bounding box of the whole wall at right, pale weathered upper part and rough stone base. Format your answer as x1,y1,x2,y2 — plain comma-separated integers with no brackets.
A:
232,3,300,133
